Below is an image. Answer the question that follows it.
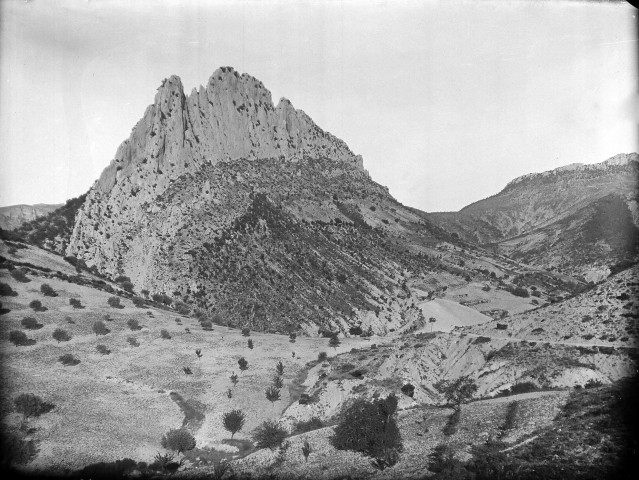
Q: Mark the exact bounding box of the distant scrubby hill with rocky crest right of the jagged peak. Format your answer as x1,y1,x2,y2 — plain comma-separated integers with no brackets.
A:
429,153,639,281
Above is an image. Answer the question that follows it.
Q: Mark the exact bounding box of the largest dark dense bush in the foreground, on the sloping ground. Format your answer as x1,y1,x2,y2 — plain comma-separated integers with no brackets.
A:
330,394,403,466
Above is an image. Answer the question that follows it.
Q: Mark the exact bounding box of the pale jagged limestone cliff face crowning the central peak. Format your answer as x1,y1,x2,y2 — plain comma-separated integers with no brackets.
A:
66,67,364,274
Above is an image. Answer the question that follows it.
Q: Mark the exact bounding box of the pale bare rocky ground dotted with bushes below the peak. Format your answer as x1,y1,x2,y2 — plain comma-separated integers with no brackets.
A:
0,240,636,478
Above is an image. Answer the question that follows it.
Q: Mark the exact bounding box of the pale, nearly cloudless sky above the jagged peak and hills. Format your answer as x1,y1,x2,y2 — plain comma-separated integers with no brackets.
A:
0,0,639,211
